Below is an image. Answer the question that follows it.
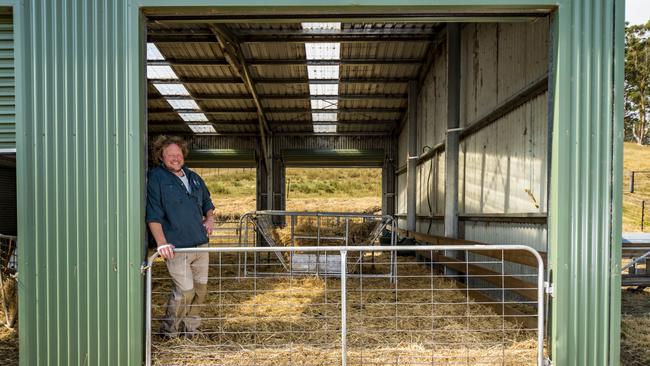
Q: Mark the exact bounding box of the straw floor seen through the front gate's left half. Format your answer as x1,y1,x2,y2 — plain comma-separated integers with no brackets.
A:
151,252,341,365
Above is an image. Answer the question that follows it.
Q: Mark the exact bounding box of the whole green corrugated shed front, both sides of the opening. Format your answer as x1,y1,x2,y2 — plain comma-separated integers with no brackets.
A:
13,0,624,366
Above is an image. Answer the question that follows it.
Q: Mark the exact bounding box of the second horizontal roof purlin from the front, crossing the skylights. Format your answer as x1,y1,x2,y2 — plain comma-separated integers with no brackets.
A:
147,58,423,66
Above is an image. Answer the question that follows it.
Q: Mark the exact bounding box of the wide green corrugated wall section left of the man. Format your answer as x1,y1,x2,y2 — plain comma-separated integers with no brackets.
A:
17,0,144,365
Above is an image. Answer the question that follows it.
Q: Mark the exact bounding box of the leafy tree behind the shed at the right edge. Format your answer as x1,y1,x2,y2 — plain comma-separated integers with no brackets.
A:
624,22,650,145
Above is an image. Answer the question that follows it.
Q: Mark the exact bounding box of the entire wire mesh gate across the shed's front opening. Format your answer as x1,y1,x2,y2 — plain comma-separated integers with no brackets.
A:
147,245,544,365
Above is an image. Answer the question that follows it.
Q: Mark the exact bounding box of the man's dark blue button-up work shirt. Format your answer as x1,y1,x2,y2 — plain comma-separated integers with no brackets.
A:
146,165,214,248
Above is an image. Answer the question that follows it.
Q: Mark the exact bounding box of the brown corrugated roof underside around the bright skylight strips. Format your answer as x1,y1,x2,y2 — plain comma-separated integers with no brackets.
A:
148,21,439,134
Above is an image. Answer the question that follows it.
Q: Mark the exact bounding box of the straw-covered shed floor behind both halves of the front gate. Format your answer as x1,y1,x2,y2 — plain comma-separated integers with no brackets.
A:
152,254,536,365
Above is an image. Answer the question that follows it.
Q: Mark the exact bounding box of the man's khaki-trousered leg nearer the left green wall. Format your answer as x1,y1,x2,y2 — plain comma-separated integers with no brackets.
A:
162,253,194,337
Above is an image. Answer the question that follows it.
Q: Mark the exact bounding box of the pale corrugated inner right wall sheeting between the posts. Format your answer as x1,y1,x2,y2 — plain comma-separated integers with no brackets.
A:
398,18,550,242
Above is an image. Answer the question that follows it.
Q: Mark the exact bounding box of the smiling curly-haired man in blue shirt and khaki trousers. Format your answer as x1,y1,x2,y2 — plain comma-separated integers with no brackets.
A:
146,136,214,338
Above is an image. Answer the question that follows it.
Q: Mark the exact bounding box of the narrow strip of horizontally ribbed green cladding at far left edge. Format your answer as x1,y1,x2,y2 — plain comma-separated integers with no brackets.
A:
0,12,16,150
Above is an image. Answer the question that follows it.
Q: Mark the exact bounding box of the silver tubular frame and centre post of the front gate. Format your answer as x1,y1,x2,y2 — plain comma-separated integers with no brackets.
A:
143,245,547,366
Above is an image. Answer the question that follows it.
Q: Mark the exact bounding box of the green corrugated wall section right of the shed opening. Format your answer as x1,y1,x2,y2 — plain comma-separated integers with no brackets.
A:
549,0,624,365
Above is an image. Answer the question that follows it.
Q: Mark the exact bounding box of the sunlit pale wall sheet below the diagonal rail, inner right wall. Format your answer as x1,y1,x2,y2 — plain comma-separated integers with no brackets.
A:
458,93,548,213
